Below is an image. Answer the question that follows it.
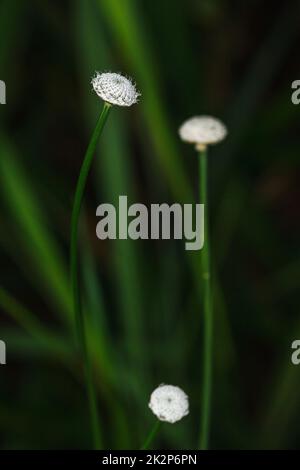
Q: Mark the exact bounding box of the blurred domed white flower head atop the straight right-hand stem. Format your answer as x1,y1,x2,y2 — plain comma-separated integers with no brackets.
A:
179,116,227,150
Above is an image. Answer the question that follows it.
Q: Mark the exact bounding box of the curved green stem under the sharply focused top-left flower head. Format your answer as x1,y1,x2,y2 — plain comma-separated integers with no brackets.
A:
70,103,111,449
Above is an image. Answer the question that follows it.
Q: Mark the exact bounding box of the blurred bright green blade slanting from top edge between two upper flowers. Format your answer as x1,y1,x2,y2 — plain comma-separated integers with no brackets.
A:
97,0,192,200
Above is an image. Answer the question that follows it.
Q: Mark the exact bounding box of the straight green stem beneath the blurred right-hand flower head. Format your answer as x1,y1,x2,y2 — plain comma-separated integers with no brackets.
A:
199,149,213,450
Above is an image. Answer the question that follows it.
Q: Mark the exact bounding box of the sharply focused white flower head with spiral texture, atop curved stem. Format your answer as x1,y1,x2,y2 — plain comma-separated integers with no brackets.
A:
92,72,140,106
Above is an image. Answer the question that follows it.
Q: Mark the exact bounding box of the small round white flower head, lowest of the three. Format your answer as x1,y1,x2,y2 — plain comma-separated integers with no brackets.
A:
149,384,189,423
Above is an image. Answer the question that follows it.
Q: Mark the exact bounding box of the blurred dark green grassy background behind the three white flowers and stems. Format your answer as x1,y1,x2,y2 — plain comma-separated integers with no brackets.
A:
0,0,300,449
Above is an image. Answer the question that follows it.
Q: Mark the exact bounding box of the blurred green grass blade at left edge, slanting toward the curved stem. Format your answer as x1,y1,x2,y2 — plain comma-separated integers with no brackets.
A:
0,135,71,319
